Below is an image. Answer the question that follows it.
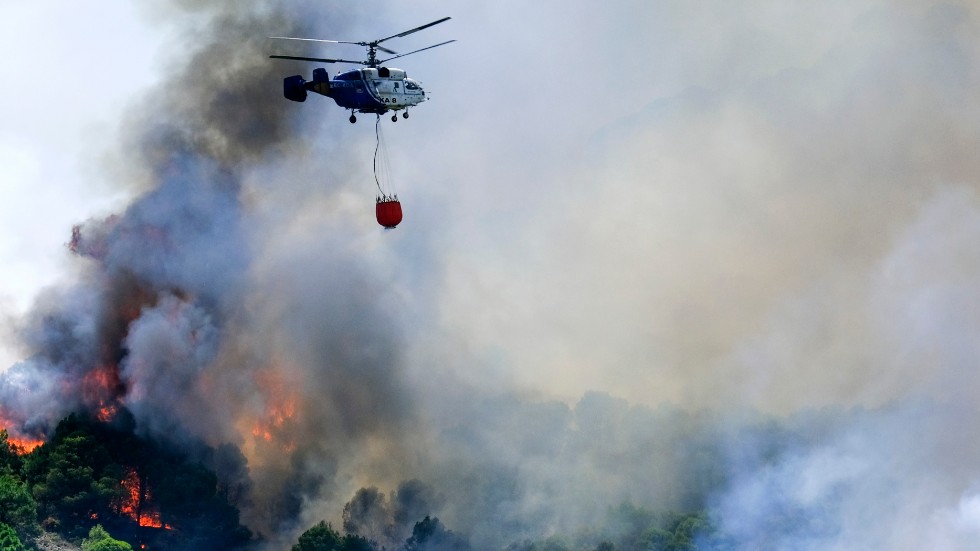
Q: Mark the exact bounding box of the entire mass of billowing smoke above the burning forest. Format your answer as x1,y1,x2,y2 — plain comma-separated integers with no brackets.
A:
0,0,980,549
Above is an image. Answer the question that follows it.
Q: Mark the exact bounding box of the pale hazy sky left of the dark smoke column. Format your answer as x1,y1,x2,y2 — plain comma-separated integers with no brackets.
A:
0,0,161,367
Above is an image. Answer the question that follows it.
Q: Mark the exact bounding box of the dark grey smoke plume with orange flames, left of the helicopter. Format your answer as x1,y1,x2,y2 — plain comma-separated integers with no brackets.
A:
0,2,410,538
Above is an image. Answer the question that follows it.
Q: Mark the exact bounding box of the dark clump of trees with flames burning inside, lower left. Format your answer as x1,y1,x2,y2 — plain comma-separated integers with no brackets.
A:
24,409,250,549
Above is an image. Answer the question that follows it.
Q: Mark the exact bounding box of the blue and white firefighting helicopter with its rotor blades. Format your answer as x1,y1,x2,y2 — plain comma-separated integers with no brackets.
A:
269,17,456,124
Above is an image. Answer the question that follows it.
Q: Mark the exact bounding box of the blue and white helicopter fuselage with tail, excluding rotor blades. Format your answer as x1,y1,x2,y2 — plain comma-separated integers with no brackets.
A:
284,67,425,115
